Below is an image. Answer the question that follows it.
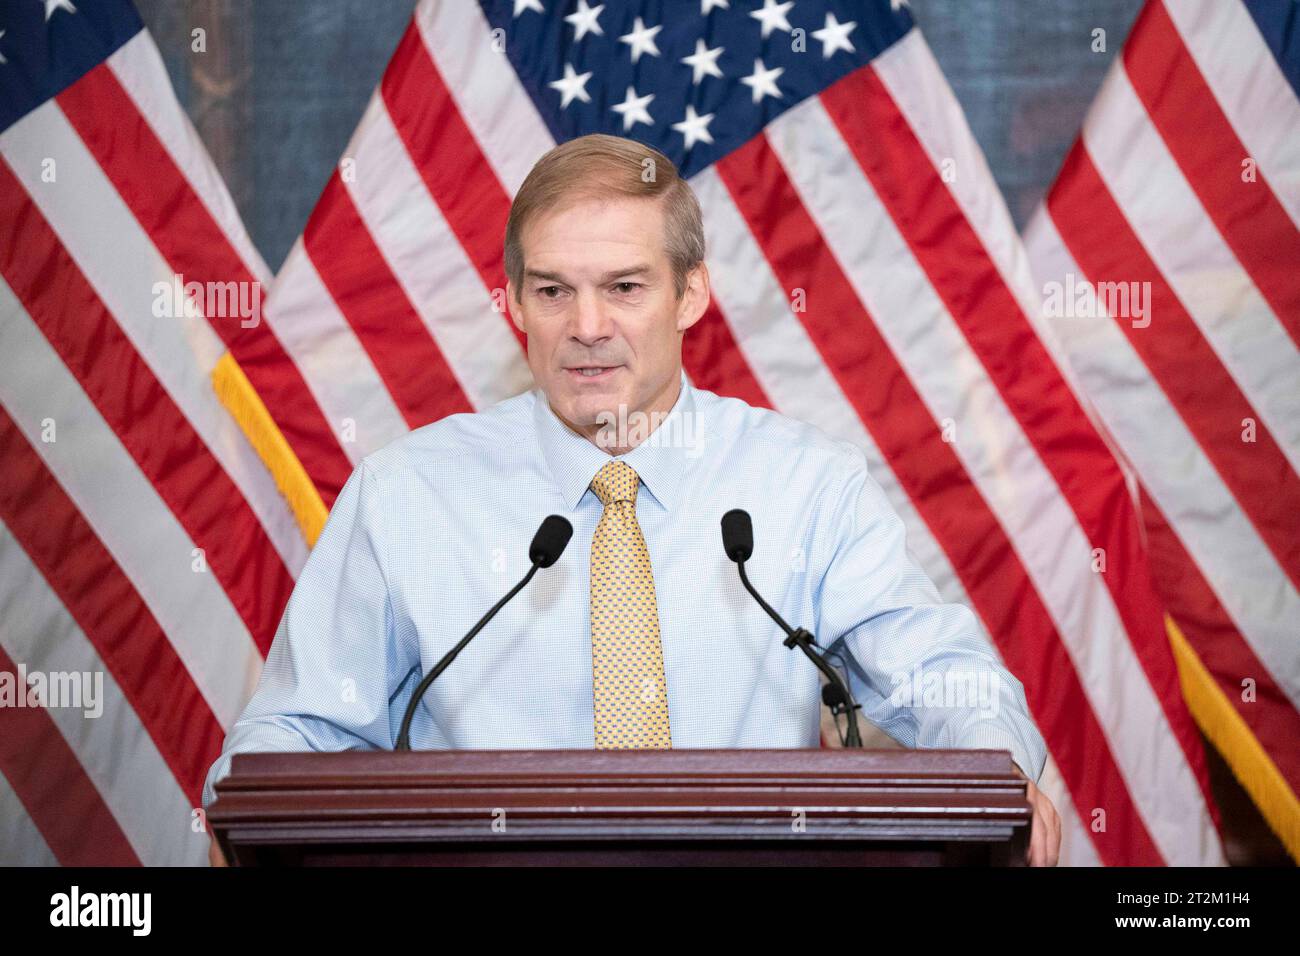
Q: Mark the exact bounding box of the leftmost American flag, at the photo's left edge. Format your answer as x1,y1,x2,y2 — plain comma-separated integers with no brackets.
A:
0,0,299,865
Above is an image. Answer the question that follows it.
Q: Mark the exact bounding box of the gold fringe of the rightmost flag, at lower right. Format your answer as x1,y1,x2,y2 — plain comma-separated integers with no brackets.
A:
1165,614,1300,861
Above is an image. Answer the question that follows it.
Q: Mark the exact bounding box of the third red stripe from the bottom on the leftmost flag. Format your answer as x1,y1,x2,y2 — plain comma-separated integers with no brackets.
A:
0,160,294,653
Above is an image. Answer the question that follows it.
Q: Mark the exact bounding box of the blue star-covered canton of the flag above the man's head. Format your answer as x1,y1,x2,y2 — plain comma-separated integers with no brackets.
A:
481,0,913,177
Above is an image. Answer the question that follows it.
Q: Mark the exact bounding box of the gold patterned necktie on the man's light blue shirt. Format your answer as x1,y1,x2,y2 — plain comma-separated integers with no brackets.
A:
592,460,672,749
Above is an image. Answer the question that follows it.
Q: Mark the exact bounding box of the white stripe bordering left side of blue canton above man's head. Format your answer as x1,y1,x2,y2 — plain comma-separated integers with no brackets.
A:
415,3,555,196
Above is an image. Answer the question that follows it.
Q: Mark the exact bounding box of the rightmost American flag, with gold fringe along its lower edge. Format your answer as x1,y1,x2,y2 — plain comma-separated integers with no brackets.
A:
1026,0,1300,858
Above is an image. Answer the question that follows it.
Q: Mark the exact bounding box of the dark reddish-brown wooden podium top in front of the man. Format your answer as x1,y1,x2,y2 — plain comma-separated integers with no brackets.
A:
208,749,1031,866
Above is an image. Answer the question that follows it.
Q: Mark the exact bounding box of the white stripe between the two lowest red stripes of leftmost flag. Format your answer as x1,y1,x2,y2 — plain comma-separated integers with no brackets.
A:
0,524,207,866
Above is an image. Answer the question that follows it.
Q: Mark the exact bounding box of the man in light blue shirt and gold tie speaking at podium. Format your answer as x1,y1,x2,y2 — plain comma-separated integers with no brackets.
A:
204,135,1060,865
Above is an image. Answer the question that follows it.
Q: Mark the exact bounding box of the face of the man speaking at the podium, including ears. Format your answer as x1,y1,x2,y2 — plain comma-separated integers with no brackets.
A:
507,198,709,437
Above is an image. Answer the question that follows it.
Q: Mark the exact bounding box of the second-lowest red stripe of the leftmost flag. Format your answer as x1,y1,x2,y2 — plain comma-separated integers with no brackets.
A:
0,408,225,806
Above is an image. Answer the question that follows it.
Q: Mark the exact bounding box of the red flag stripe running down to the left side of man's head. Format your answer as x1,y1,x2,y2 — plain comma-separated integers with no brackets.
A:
380,20,528,350
